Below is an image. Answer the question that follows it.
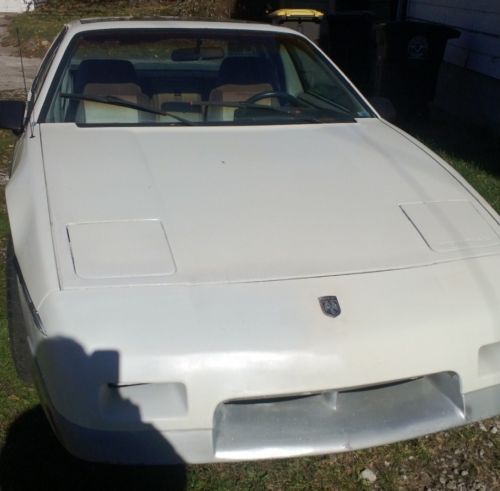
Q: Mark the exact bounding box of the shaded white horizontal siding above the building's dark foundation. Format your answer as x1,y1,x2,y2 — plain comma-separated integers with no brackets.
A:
408,0,500,79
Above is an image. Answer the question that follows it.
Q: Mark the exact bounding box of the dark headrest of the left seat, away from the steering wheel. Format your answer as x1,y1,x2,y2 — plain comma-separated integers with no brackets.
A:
75,60,137,93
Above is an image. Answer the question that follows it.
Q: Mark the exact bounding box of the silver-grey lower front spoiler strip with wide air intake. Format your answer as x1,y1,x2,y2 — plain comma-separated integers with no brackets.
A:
44,372,500,465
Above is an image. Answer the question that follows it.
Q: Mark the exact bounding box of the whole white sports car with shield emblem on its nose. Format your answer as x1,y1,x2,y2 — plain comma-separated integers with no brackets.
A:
0,19,500,464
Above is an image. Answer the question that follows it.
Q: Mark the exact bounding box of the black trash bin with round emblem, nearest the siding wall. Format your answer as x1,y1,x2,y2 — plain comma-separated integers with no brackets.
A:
371,21,460,116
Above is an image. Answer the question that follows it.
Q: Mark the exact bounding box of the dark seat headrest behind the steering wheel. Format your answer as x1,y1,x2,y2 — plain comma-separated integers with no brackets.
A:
218,56,272,85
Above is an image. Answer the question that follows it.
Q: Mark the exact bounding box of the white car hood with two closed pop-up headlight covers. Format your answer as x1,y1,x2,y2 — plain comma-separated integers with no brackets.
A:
41,119,499,287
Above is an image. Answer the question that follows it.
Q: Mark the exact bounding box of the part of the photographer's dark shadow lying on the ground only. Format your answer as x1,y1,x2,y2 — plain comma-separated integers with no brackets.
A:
0,406,186,491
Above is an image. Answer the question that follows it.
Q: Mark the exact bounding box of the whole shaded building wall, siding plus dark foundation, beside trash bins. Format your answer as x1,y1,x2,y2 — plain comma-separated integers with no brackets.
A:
407,0,500,134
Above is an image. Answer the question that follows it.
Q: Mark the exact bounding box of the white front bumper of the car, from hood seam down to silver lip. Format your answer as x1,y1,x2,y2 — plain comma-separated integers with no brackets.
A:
33,256,500,464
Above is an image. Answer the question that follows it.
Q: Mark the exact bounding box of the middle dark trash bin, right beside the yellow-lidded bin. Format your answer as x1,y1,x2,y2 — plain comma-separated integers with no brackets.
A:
320,11,379,94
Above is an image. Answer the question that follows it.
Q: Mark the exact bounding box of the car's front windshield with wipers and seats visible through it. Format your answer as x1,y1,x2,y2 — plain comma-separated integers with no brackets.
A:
41,29,373,125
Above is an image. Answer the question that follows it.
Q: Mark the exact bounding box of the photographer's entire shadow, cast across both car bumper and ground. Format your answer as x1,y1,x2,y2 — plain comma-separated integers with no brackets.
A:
0,338,186,491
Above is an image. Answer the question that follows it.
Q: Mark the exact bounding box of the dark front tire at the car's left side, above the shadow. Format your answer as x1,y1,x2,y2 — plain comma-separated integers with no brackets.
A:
5,240,33,385
